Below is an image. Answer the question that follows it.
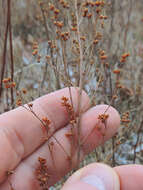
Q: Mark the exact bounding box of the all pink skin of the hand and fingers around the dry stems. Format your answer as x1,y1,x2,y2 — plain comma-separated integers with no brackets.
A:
0,87,143,190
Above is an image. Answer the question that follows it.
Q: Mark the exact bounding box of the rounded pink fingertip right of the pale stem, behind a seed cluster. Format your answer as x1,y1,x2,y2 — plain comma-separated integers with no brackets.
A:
81,105,120,154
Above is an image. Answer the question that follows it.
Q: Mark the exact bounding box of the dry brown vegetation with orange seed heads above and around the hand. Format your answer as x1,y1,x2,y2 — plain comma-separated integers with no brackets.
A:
0,0,143,189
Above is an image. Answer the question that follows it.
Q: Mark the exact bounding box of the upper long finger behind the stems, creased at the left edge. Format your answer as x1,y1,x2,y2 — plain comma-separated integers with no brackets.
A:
0,88,89,182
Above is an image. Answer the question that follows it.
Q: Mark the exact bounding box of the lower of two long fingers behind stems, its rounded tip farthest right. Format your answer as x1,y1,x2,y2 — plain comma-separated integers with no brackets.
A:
0,105,120,190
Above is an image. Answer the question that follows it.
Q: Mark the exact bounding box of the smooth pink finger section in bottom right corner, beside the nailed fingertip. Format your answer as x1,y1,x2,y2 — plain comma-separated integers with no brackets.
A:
114,165,143,190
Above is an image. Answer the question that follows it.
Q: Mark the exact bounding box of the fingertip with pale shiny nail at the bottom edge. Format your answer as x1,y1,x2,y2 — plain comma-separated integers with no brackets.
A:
62,163,120,190
